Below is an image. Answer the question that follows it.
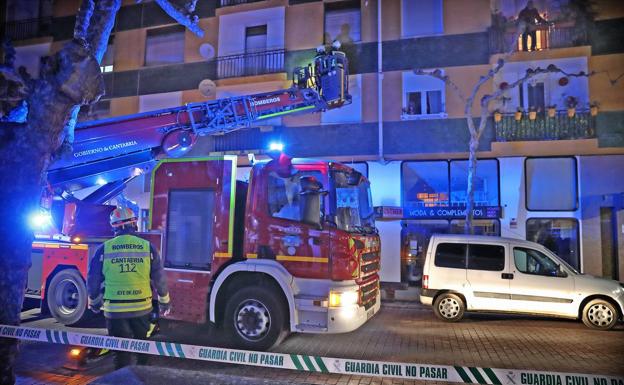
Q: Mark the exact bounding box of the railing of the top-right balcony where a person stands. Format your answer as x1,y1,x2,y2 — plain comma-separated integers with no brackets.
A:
489,23,588,54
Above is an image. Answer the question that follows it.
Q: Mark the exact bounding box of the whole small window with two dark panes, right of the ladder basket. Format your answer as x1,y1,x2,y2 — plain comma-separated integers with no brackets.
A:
401,72,446,119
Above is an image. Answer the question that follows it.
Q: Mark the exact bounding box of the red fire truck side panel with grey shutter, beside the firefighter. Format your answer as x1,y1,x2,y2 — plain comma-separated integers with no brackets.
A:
150,156,236,323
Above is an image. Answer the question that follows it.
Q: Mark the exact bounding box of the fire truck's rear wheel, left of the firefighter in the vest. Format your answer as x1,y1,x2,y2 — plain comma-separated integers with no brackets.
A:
46,269,91,325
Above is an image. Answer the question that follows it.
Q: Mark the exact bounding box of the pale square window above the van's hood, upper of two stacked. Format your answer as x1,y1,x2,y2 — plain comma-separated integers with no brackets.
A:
525,157,578,211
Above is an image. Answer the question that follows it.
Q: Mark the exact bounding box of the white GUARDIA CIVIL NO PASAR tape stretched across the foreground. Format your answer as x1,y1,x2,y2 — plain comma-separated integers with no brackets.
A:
0,325,624,385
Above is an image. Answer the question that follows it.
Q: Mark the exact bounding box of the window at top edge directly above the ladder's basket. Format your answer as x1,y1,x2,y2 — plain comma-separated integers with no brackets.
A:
325,1,361,45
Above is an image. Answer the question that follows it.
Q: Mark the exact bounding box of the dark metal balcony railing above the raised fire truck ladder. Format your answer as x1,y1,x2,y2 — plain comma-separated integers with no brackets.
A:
217,49,284,79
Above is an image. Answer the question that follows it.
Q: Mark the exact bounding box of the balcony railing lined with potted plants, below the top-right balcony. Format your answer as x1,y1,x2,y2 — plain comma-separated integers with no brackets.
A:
494,111,596,142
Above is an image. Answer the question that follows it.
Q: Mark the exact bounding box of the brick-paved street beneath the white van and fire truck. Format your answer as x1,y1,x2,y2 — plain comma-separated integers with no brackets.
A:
13,302,624,384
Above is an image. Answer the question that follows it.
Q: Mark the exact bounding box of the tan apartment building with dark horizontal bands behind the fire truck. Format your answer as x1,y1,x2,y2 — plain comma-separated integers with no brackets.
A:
3,0,624,282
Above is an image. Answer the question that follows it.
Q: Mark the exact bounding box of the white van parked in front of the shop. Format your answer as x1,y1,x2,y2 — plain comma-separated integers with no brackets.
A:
420,234,624,330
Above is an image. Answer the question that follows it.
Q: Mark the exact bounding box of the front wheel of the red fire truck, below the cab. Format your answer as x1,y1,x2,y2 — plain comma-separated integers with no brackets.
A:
223,286,288,350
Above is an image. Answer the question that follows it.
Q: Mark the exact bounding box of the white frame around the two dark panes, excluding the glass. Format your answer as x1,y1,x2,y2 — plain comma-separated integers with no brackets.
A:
401,70,448,120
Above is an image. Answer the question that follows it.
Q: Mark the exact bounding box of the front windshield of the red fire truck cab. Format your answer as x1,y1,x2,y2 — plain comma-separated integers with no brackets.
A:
330,170,375,234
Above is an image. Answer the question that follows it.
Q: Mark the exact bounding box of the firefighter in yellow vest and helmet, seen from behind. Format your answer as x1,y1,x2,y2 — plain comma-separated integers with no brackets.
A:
87,207,169,369
